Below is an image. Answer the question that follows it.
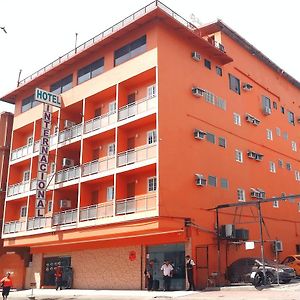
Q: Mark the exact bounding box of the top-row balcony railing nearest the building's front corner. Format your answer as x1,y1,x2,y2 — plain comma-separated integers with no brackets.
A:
118,95,156,121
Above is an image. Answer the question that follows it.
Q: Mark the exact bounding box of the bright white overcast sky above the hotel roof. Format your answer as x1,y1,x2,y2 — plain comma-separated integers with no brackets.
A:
0,0,300,112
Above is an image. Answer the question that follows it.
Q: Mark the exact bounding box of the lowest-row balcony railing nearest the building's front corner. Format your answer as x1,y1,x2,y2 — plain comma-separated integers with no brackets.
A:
116,193,157,215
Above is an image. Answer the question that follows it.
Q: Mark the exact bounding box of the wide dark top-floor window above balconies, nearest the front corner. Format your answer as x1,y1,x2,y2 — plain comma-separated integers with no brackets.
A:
114,35,146,66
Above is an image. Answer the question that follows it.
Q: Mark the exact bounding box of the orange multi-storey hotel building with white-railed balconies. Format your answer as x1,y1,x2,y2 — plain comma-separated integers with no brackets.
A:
2,1,300,289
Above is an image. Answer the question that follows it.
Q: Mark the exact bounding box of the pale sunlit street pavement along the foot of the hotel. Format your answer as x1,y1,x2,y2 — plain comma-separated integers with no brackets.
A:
8,281,300,300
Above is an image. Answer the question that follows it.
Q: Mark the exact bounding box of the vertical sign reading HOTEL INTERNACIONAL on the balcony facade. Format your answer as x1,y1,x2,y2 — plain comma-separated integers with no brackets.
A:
35,88,61,217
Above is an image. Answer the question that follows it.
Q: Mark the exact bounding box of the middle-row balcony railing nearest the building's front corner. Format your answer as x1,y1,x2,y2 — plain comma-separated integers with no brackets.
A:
117,144,156,167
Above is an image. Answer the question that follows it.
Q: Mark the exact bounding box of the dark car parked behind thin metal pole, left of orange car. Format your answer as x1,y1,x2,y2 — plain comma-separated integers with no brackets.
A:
225,257,296,285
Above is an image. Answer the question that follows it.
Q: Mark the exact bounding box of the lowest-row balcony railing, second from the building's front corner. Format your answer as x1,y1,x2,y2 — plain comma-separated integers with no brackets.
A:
79,201,114,221
